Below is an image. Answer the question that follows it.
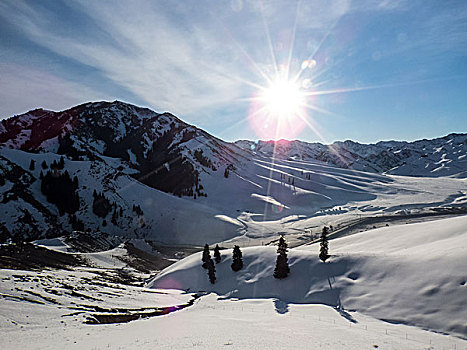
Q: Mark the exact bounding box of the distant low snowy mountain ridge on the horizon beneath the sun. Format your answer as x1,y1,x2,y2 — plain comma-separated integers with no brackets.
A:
236,134,467,178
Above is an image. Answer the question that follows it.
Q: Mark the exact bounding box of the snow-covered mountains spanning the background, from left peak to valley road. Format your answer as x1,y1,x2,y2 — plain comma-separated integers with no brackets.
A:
0,101,467,244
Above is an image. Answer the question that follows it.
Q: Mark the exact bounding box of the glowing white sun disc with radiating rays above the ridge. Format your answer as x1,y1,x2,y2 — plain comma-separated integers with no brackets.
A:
260,79,305,119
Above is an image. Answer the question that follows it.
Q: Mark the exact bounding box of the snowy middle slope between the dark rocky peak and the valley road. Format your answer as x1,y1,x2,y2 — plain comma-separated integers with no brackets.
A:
0,140,467,245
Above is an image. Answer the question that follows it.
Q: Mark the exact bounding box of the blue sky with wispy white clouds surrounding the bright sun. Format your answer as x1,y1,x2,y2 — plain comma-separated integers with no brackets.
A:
0,0,467,143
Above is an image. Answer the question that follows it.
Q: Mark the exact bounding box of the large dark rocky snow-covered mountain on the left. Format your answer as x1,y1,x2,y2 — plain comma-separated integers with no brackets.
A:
0,101,252,240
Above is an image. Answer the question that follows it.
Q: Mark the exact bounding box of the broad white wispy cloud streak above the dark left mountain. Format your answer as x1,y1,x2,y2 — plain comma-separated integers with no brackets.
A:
0,1,256,119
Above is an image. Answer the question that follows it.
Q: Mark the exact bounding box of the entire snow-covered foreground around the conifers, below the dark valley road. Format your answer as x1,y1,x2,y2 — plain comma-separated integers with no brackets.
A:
0,216,467,350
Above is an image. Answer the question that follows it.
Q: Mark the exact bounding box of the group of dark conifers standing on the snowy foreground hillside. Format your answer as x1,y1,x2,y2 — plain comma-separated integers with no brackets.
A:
201,226,330,284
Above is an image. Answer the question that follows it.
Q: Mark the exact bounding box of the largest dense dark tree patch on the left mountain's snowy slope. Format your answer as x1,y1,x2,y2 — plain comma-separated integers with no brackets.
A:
40,170,79,215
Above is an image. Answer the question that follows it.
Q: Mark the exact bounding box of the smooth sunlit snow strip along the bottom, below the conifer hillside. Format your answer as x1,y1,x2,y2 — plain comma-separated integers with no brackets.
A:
0,291,467,350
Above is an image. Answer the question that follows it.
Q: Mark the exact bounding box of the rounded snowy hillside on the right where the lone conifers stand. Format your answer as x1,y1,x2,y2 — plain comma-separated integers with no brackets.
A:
148,216,467,337
